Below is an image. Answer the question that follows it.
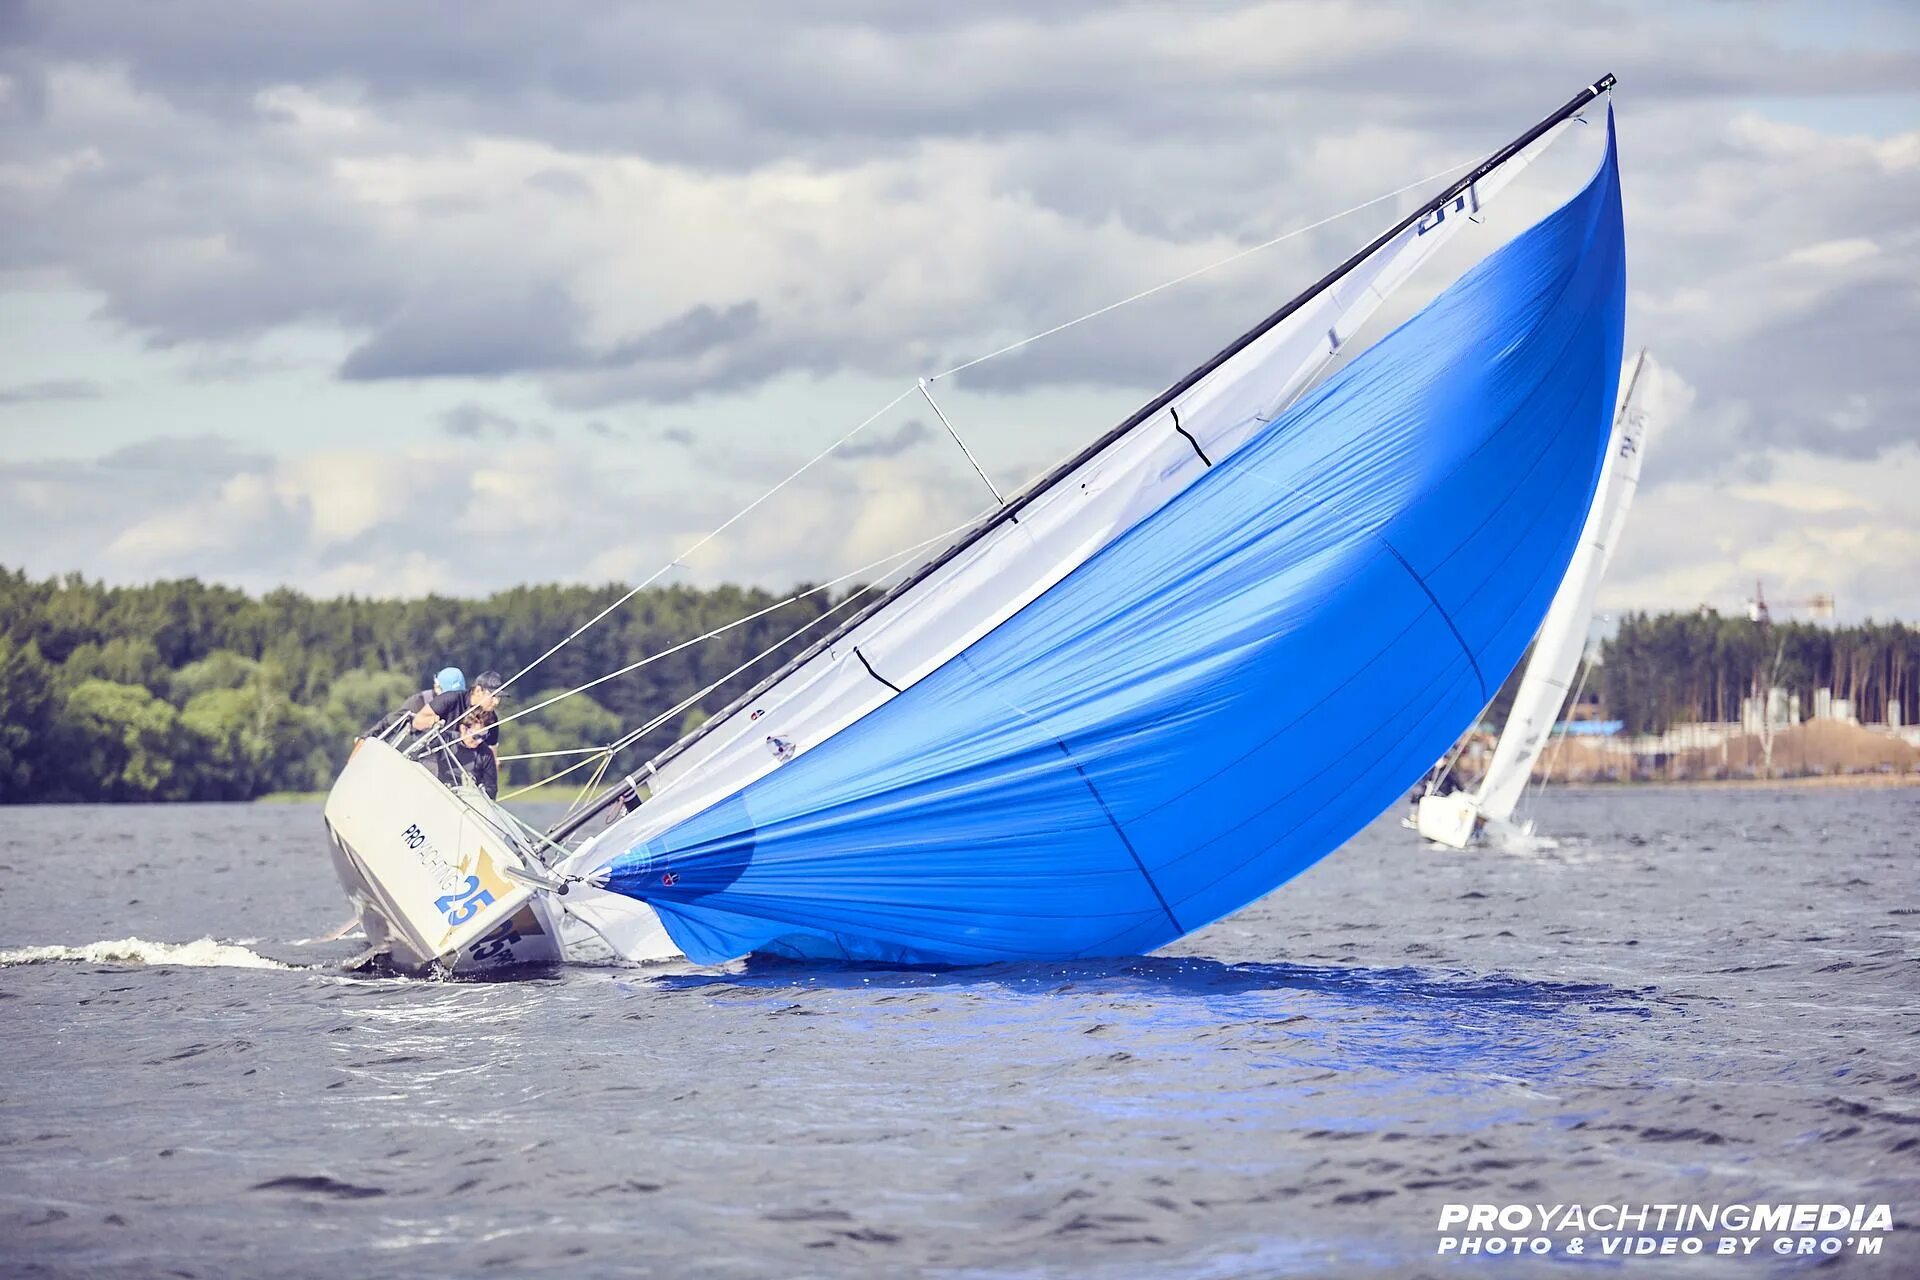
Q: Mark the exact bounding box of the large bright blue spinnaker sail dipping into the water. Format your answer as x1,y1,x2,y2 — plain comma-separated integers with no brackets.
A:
603,119,1626,963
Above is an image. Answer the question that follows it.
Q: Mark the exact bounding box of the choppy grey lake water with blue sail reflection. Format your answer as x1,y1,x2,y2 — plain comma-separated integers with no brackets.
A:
0,789,1920,1278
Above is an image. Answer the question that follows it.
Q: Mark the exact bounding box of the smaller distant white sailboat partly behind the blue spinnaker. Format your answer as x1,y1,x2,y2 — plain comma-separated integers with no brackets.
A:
1413,347,1649,852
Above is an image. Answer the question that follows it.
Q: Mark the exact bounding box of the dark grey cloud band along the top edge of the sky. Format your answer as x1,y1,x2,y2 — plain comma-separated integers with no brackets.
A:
10,0,1920,165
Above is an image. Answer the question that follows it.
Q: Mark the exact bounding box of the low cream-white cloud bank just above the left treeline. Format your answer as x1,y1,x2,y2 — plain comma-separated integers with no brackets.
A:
0,426,979,597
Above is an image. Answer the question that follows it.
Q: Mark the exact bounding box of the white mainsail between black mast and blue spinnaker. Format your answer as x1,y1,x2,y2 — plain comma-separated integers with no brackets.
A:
561,102,1611,896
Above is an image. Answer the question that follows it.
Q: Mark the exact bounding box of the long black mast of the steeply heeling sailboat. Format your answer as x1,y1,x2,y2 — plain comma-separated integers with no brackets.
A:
547,71,1615,842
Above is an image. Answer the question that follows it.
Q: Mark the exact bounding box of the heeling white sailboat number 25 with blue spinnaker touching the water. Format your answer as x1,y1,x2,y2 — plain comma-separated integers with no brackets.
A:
326,75,1626,971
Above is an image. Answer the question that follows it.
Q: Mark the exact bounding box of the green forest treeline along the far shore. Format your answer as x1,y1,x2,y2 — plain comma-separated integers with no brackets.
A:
0,570,1920,802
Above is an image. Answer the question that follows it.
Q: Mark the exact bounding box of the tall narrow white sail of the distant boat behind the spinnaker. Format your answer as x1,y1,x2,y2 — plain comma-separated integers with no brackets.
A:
1475,351,1647,821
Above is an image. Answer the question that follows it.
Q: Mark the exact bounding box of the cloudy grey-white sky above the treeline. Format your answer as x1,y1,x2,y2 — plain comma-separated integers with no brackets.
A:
0,0,1920,618
